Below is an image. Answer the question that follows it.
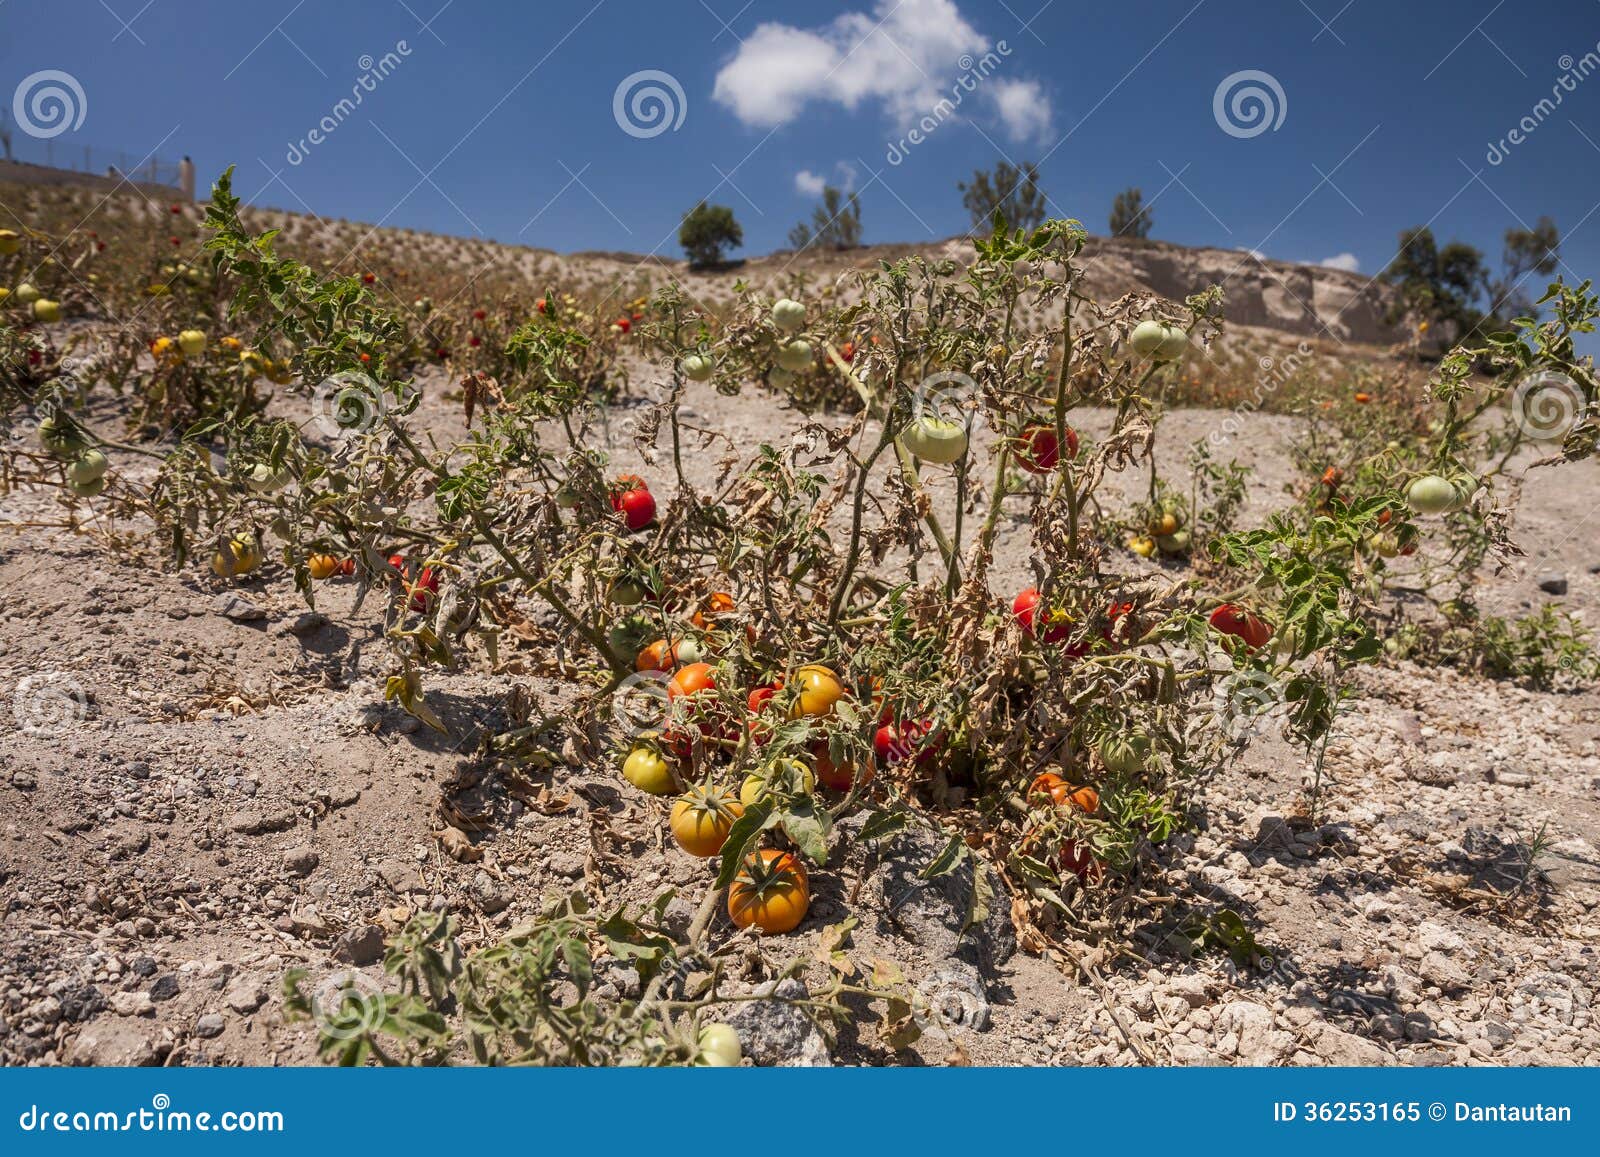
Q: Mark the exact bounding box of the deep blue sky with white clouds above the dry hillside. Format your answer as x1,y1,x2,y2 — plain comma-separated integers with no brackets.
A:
0,0,1600,302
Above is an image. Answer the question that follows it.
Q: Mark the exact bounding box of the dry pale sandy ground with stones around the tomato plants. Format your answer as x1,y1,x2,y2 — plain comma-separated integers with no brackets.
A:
0,356,1600,1064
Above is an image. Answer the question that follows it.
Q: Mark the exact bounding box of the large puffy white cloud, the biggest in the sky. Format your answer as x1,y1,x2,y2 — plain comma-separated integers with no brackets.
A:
712,0,1051,139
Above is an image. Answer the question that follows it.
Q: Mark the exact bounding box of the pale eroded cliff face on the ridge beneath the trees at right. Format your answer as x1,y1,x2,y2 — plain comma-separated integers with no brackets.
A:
1083,237,1403,344
